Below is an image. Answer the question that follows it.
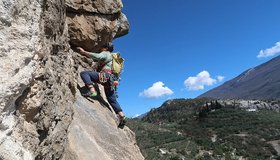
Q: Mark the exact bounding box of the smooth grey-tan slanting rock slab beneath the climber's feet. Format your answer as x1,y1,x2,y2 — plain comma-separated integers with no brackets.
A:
63,92,144,160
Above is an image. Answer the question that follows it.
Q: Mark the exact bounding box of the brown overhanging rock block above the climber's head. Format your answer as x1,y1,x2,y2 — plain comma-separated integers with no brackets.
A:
66,0,129,52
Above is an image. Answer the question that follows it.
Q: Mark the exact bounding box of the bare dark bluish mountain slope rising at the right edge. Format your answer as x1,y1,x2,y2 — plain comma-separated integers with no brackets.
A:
198,56,280,99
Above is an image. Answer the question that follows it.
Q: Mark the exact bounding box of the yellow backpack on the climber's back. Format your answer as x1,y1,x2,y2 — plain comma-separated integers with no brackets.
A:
112,52,124,77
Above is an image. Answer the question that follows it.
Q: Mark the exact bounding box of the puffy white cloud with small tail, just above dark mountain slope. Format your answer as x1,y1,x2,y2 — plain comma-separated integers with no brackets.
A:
184,71,224,91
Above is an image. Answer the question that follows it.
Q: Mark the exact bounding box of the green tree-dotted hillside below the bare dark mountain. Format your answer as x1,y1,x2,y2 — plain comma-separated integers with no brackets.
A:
128,99,280,160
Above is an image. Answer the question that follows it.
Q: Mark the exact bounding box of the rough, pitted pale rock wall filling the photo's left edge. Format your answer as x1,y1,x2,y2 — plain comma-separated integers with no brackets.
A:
0,0,75,160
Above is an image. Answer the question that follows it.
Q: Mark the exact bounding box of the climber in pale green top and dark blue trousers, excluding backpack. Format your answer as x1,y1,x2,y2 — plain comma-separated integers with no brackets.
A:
77,42,126,128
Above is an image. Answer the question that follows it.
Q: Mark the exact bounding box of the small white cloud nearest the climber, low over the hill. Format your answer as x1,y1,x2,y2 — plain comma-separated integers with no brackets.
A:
139,81,174,98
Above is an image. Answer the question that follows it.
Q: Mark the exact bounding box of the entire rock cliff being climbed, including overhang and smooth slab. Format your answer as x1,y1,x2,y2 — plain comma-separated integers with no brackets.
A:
0,0,143,160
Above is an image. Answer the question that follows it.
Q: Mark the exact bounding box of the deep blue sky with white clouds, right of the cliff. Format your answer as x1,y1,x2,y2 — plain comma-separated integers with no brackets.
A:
114,0,280,116
